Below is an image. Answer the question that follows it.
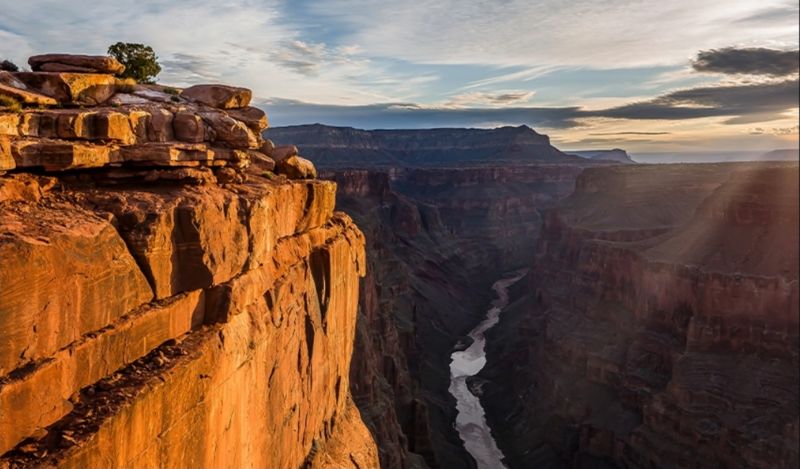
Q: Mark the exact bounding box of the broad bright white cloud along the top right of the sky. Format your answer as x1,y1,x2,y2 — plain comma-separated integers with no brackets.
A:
304,0,798,69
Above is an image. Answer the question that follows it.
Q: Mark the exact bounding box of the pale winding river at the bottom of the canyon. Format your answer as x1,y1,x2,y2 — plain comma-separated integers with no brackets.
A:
450,269,527,469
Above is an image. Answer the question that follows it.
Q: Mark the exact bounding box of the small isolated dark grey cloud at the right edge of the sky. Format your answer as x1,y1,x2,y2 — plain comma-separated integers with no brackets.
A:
692,47,800,77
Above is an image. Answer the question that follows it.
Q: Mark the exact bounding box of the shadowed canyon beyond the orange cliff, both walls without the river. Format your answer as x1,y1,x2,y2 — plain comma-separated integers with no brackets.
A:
266,125,800,468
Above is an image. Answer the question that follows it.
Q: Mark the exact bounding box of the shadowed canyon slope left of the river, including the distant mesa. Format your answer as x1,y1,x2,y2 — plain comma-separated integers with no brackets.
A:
265,125,608,468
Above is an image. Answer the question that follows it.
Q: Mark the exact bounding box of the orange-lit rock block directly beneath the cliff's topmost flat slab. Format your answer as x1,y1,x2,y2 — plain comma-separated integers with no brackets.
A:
14,72,117,105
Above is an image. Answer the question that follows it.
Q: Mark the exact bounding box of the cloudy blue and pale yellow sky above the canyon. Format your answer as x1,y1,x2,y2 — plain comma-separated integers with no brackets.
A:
0,0,800,152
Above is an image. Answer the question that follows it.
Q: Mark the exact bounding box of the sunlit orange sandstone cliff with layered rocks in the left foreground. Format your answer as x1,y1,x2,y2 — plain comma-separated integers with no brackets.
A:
0,56,378,468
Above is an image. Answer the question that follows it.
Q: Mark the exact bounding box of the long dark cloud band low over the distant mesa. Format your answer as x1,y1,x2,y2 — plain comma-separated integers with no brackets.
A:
262,78,800,129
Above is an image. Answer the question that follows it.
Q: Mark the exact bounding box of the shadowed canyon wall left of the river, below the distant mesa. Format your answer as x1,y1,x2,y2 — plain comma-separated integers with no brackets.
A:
322,165,583,468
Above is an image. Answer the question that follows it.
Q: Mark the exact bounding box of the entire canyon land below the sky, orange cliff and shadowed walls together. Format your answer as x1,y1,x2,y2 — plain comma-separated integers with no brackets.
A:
0,54,800,469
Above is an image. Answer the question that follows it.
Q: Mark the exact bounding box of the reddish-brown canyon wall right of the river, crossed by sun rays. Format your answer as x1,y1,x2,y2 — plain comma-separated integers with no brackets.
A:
483,163,800,468
